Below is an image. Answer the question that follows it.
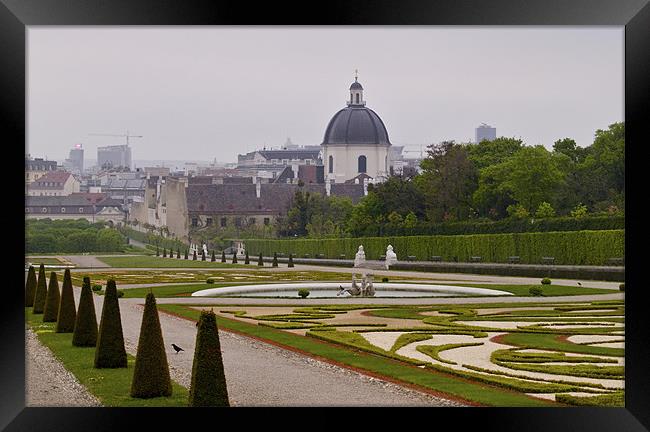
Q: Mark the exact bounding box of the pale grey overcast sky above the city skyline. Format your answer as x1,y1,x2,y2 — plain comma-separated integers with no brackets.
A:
26,26,624,162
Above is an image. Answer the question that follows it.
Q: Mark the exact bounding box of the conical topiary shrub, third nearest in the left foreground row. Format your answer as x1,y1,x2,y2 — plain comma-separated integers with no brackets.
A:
95,279,127,368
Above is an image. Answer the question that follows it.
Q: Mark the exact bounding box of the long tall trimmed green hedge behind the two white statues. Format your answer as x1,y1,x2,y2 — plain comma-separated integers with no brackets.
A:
246,230,625,265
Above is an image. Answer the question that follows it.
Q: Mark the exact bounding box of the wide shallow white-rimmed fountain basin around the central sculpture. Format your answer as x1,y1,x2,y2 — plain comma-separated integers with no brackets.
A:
192,282,513,297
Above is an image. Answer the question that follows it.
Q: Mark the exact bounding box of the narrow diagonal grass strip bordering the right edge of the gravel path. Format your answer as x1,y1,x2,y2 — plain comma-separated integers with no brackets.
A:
158,304,557,407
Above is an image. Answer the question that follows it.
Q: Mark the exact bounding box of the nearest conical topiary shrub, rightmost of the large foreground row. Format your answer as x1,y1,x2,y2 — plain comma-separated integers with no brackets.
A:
189,311,230,407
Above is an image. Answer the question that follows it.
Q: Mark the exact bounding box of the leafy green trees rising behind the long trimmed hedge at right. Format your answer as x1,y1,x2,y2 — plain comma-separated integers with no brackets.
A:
276,122,625,238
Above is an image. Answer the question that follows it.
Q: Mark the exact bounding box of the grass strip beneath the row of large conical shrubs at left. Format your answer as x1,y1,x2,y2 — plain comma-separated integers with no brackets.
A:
25,308,189,407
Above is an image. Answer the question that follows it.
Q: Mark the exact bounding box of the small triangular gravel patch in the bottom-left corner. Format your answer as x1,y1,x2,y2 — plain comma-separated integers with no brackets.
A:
25,329,101,407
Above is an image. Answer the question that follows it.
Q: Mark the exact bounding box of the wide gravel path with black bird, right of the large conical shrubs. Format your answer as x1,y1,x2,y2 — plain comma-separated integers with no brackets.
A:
75,288,463,406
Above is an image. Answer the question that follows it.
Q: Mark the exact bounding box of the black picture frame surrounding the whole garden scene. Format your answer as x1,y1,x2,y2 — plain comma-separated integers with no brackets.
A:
0,0,650,432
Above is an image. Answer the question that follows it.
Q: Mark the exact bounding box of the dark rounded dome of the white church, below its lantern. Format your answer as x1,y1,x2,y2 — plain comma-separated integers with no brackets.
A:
322,105,390,145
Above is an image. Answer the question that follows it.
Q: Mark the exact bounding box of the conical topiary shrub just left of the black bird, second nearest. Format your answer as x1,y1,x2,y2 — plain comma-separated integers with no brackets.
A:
131,293,172,399
